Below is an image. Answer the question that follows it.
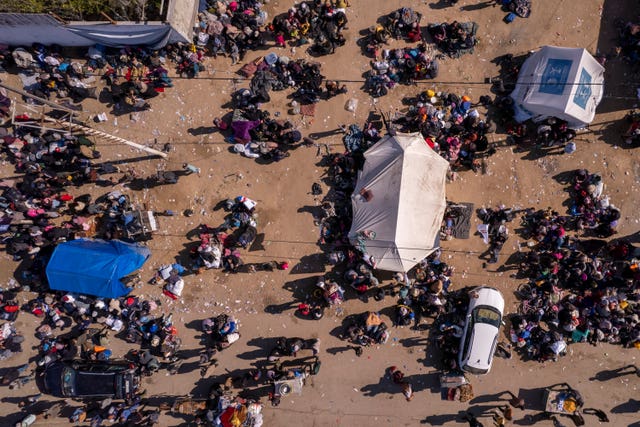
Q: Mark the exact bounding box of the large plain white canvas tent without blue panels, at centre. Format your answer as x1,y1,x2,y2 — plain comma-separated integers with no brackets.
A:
349,133,449,272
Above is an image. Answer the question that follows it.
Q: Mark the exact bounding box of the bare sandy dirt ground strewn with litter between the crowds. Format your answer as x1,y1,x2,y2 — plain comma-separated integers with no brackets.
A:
0,0,640,426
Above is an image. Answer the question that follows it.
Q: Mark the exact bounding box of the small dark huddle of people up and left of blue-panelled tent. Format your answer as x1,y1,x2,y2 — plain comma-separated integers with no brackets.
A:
427,21,478,58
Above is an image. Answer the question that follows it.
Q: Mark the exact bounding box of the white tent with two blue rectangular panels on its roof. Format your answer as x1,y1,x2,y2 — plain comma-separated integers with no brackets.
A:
511,46,604,129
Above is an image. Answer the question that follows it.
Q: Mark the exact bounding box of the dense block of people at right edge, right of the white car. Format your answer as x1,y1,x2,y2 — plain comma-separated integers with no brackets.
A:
512,237,640,361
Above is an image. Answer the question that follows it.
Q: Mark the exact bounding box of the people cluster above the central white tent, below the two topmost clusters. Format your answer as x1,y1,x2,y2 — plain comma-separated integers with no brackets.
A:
365,44,439,97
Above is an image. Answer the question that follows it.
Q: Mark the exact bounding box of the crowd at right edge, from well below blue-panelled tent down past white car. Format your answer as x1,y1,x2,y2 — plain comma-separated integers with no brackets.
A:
512,169,640,360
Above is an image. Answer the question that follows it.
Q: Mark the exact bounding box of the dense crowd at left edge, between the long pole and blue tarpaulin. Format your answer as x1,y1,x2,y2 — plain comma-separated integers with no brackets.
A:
0,126,113,260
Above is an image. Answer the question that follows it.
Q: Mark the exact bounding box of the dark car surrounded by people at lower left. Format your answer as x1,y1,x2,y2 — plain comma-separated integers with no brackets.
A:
44,361,140,400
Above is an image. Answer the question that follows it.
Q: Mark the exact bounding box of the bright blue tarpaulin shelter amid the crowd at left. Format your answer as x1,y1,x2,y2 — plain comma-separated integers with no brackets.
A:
46,239,151,298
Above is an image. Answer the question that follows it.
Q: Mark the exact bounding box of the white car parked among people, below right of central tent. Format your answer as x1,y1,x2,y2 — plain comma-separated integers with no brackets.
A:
458,287,504,375
